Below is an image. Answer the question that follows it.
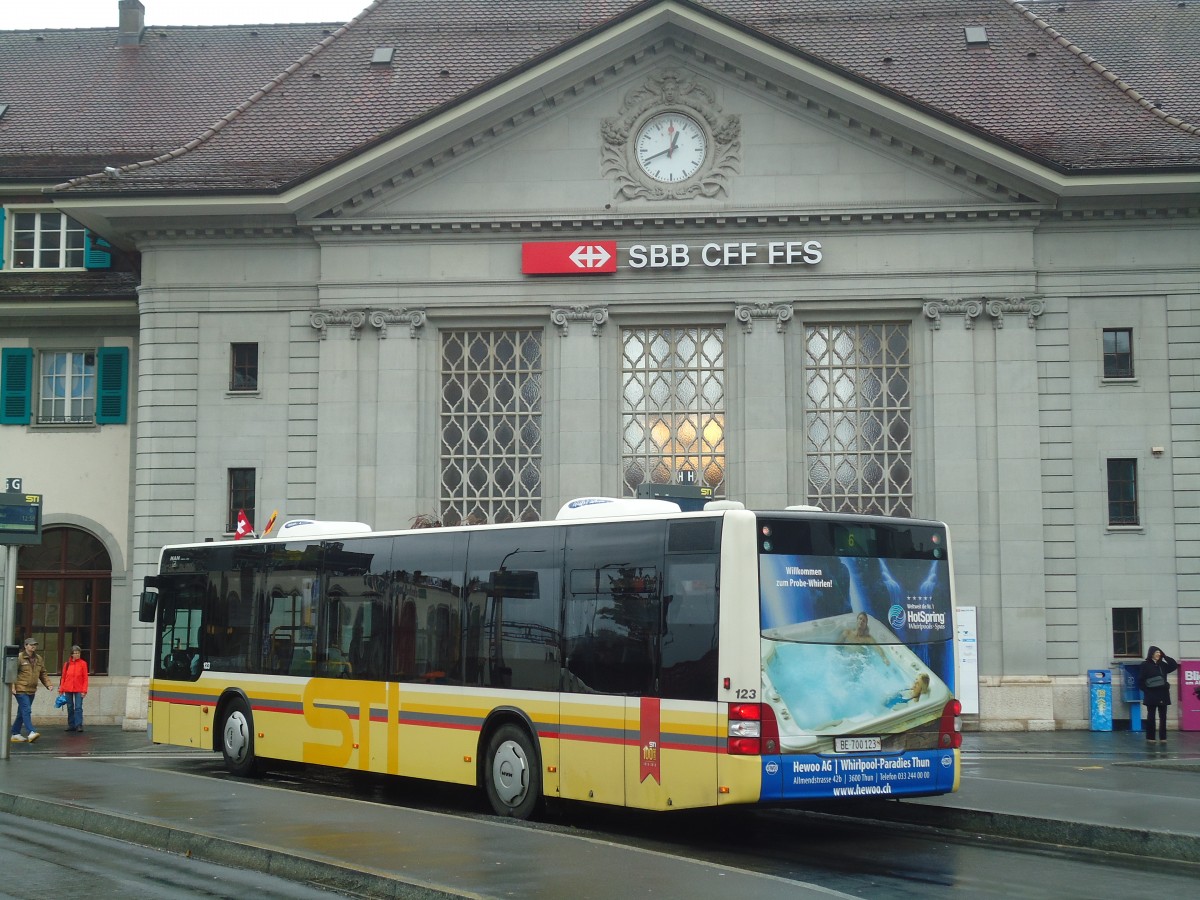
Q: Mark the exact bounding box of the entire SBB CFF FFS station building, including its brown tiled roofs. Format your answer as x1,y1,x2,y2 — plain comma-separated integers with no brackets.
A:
0,0,1200,730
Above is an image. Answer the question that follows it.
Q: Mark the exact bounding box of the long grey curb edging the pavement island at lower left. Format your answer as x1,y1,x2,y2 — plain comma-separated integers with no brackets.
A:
0,793,470,900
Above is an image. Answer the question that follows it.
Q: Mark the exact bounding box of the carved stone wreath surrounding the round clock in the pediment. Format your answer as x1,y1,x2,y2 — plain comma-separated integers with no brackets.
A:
600,68,742,200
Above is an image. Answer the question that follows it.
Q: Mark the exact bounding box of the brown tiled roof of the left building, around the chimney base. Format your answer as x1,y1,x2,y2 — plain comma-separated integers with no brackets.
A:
0,17,340,184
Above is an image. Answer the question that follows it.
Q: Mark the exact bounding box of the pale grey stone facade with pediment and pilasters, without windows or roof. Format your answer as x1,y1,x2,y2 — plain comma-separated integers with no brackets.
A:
0,1,1200,730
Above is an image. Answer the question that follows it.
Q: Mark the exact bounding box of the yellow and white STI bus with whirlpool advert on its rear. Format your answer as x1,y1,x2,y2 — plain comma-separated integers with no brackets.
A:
139,498,961,818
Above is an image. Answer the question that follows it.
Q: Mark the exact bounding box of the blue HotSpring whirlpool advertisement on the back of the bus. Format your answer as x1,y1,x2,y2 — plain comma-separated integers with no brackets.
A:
758,554,955,798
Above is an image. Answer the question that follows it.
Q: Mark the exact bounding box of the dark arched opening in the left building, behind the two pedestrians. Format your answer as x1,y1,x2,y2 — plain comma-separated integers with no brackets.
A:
12,528,113,674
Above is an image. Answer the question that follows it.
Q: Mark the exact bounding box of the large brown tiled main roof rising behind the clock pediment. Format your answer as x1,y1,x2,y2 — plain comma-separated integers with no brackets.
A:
0,0,1200,193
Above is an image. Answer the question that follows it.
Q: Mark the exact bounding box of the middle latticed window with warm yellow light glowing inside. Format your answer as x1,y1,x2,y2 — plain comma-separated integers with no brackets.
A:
620,326,725,497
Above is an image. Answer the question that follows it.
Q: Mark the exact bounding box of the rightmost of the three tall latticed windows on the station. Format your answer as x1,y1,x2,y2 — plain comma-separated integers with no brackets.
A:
804,323,912,516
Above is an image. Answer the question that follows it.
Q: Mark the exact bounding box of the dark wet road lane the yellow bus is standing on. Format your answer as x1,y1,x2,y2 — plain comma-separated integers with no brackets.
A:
140,754,1200,900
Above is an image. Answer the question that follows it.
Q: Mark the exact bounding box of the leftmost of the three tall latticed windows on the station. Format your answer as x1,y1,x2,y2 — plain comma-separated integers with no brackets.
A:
440,330,542,526
